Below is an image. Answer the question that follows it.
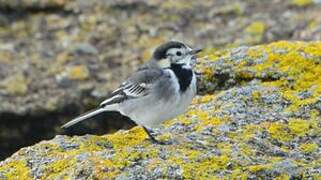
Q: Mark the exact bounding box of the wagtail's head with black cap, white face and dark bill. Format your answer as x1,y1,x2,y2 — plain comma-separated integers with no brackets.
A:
153,41,201,68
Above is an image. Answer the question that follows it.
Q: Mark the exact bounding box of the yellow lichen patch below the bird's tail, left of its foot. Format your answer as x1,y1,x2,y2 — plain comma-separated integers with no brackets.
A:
44,127,158,179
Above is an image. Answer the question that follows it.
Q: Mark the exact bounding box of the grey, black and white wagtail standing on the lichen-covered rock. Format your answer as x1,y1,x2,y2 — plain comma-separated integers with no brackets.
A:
62,41,201,143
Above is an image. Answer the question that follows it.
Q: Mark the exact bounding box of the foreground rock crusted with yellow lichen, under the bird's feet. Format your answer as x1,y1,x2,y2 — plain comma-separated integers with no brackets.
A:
0,41,321,179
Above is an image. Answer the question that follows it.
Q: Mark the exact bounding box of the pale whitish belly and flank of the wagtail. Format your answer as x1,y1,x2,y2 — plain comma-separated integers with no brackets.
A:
122,70,196,128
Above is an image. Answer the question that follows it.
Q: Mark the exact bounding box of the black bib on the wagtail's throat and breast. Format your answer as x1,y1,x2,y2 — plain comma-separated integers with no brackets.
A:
170,64,193,92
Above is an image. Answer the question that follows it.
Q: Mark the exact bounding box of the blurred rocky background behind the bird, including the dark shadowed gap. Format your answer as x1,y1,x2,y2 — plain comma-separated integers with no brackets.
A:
0,0,321,159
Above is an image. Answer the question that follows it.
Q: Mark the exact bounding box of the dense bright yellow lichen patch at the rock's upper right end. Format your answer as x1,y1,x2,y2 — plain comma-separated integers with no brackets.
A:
248,41,321,111
